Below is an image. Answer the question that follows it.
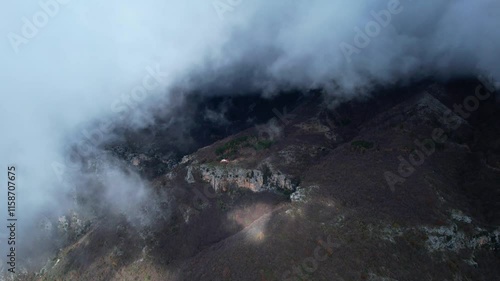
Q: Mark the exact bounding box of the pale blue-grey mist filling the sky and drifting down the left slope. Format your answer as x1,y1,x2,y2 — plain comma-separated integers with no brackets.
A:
0,0,500,272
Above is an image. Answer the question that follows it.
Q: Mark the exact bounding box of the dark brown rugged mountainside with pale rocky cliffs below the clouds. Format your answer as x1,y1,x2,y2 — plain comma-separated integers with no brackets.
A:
15,80,500,281
